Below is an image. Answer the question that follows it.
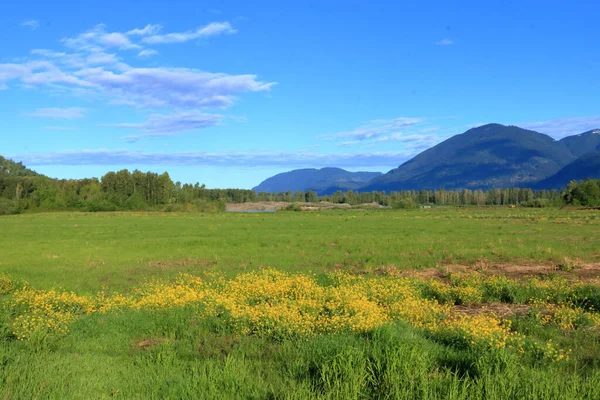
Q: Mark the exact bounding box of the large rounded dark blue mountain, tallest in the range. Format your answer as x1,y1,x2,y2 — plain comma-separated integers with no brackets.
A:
360,124,576,191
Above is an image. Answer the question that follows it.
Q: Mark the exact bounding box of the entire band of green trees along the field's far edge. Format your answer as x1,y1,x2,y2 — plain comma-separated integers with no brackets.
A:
0,160,600,214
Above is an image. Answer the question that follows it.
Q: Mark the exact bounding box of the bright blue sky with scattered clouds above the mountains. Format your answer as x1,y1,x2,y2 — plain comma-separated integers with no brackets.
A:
0,0,600,188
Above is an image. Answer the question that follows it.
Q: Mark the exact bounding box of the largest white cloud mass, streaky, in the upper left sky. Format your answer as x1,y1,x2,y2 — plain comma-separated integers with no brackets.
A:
0,22,276,110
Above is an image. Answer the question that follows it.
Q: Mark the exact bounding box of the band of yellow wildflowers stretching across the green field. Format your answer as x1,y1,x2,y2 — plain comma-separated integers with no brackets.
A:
0,269,600,360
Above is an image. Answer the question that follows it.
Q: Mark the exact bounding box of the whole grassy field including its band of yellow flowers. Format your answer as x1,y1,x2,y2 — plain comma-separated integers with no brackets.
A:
0,208,600,399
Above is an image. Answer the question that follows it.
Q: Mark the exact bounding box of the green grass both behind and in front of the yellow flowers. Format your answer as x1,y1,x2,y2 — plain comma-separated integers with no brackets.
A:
0,208,600,399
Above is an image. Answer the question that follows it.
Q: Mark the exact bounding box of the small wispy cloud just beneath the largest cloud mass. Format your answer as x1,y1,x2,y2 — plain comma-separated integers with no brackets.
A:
102,112,224,142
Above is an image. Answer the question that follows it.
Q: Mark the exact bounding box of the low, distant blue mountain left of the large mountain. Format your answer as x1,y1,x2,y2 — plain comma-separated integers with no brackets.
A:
252,168,381,195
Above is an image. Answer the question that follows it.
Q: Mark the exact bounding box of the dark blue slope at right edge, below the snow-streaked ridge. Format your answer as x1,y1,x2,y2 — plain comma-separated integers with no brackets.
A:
533,150,600,189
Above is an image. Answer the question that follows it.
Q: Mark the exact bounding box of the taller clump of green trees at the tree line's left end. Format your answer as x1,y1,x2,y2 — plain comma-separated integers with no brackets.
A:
0,168,256,214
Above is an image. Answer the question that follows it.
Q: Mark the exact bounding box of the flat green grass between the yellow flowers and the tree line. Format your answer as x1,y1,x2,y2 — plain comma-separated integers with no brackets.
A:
0,208,600,293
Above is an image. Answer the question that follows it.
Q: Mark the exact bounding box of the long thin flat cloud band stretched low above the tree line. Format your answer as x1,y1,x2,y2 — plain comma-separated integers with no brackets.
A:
9,149,410,169
